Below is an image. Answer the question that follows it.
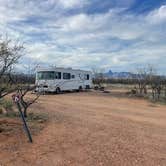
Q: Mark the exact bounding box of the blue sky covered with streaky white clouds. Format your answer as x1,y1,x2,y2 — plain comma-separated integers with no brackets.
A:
0,0,166,75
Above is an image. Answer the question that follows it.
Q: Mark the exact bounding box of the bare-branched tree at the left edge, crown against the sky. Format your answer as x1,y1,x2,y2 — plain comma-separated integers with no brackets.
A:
0,37,24,98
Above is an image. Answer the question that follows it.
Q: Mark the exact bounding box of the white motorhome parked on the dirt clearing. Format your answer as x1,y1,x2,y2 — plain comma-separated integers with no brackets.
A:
36,67,92,93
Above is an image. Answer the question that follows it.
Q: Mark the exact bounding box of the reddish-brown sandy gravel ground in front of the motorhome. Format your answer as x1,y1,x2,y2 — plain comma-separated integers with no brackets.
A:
0,92,166,166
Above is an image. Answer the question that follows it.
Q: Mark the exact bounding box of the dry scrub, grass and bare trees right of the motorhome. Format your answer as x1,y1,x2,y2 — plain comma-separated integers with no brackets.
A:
93,65,166,103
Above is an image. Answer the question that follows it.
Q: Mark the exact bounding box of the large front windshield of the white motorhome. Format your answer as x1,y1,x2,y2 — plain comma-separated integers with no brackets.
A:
37,71,55,80
